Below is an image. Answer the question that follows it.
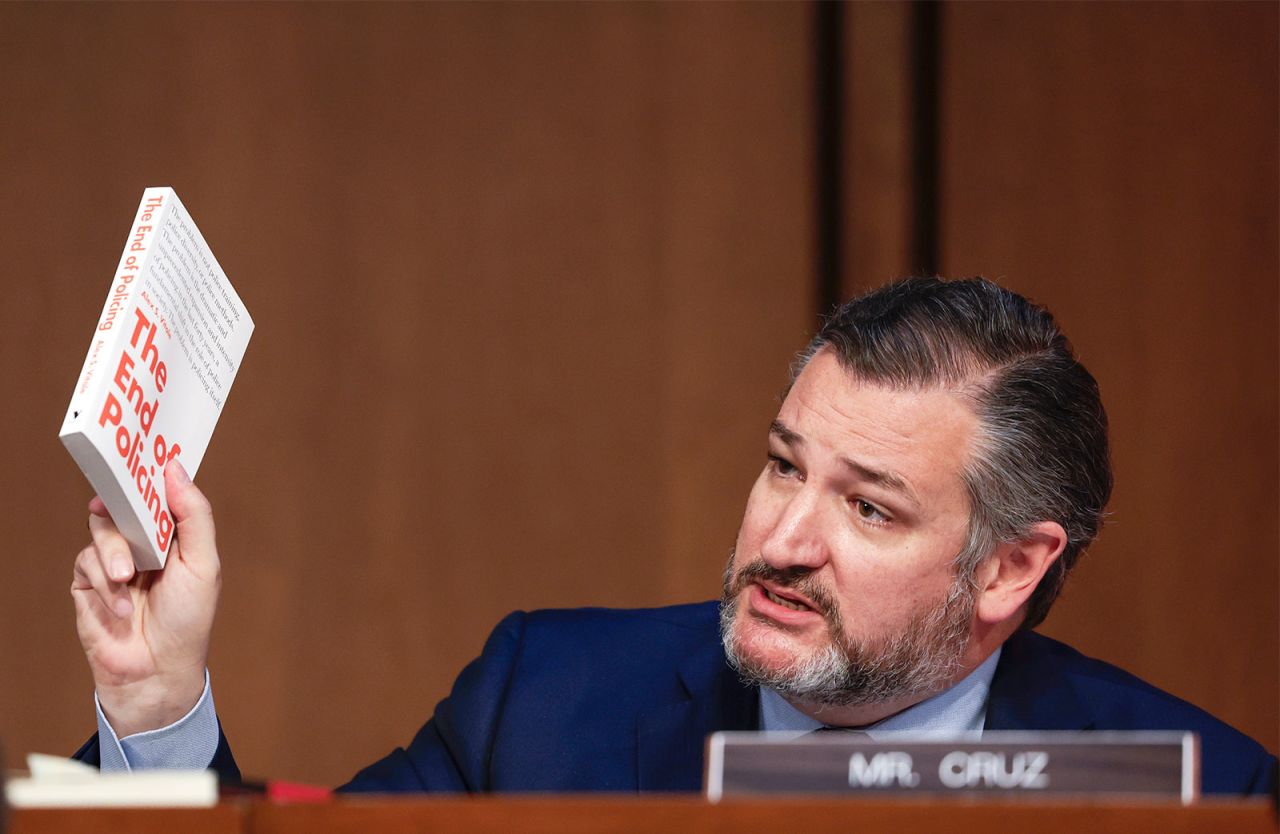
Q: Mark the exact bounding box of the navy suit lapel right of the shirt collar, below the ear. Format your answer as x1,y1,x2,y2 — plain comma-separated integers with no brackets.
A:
986,632,1093,730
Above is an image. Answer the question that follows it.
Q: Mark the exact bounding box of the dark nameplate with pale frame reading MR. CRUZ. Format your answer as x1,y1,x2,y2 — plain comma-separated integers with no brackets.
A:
705,732,1199,805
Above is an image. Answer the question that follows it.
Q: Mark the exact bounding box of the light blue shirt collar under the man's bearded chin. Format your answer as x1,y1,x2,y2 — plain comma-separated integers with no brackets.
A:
760,649,1001,739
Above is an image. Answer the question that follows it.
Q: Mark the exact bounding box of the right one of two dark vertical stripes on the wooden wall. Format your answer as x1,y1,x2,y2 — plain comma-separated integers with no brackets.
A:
911,0,942,275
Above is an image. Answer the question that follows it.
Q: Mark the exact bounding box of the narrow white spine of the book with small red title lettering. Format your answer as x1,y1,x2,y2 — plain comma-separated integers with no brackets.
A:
59,188,174,435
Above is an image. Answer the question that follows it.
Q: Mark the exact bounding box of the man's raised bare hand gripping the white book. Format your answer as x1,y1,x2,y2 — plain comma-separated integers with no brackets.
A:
72,459,221,738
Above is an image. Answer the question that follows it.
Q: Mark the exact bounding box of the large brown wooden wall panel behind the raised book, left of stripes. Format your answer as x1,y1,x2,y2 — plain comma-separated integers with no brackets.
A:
0,4,813,783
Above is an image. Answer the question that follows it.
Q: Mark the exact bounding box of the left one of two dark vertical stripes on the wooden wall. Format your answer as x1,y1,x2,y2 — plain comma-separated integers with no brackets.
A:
813,0,845,316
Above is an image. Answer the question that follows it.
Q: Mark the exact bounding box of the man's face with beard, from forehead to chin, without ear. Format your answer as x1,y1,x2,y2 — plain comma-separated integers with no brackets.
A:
722,350,977,706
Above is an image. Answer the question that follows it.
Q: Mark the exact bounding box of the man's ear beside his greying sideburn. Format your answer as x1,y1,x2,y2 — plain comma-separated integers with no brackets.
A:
974,522,1066,626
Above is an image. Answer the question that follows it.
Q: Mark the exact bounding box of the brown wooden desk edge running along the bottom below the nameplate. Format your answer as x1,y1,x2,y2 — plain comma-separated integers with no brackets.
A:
10,797,1277,834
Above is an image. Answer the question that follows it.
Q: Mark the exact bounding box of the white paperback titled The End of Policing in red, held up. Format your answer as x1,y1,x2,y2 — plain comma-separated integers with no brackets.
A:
58,187,253,570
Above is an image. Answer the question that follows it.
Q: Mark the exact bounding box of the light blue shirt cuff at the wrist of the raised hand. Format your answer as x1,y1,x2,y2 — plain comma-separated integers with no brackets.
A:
93,669,219,773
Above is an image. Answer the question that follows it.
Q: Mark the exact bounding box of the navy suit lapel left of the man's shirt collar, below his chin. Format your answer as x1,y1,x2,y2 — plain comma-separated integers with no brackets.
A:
636,634,760,792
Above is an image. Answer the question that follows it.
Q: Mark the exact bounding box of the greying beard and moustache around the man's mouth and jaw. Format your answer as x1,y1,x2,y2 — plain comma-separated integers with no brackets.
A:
719,554,977,707
